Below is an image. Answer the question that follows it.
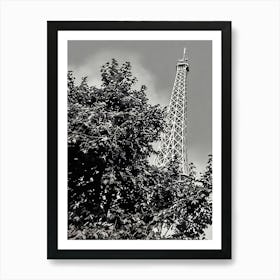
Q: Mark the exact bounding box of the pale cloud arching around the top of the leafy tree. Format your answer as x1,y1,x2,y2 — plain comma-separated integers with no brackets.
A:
68,50,162,104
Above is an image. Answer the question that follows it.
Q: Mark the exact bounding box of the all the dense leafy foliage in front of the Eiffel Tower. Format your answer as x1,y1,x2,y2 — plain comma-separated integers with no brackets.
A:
68,59,212,239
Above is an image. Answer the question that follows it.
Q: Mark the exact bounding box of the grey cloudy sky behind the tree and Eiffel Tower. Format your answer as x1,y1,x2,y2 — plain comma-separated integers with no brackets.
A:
68,41,212,171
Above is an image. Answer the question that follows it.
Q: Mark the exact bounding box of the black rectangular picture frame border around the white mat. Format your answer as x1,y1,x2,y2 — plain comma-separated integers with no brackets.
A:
47,21,231,259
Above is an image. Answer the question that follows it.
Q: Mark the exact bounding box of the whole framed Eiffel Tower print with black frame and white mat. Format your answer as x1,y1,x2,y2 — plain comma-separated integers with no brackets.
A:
48,21,231,259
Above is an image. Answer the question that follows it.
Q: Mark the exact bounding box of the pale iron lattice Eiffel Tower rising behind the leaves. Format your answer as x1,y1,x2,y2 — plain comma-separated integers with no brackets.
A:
155,48,189,175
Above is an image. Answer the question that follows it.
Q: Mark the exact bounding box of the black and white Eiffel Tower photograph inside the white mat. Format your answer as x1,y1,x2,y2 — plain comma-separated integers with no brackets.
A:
68,41,212,240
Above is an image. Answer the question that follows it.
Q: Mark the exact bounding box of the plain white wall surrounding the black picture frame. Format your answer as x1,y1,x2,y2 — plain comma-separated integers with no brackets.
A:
0,0,280,280
